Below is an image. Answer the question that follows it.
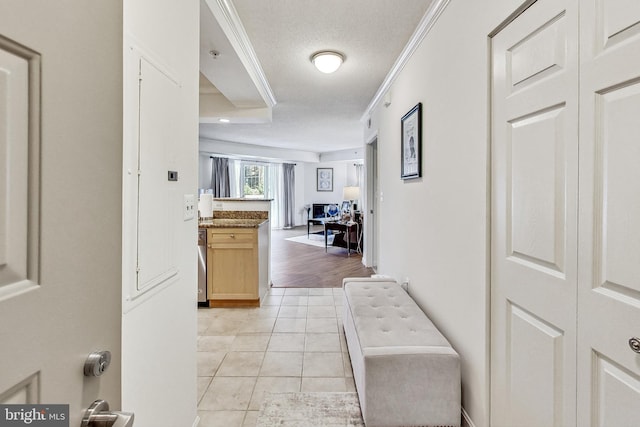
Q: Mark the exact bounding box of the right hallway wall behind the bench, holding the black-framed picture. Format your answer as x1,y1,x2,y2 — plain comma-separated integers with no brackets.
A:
364,0,521,427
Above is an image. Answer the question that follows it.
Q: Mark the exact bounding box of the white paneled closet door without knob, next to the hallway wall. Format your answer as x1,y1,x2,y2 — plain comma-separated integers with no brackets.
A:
491,0,578,426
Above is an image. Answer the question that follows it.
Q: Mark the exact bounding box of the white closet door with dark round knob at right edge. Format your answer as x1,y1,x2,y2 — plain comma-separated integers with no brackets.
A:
578,0,640,427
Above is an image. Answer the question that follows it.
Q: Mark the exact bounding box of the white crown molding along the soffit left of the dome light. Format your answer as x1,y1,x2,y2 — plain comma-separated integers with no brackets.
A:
206,0,277,108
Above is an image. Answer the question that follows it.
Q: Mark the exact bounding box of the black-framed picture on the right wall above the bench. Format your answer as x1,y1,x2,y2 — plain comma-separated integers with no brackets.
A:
400,102,422,179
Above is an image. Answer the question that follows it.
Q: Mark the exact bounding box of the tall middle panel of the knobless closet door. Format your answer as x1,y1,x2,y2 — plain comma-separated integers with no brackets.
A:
506,105,566,277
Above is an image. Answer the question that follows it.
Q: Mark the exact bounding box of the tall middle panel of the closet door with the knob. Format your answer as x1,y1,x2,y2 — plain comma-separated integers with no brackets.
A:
595,82,640,294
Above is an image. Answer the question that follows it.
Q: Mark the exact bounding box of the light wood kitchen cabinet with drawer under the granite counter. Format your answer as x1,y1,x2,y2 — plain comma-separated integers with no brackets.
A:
207,221,268,307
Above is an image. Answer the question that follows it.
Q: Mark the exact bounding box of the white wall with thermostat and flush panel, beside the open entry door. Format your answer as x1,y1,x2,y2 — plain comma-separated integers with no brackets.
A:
122,0,200,427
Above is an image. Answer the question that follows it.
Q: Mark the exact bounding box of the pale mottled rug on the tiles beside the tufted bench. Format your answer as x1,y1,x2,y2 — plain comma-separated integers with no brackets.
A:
256,393,364,427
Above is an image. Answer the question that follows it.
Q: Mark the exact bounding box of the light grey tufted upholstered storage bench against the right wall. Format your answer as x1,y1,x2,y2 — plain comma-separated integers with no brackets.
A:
342,277,461,427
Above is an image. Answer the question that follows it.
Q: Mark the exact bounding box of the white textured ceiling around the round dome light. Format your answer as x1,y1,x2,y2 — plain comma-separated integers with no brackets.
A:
200,0,431,153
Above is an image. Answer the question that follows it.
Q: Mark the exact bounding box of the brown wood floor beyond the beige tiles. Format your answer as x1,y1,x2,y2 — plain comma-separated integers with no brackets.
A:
271,226,374,288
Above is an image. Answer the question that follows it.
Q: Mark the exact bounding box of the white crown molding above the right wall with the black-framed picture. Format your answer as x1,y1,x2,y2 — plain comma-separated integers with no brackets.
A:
360,0,451,122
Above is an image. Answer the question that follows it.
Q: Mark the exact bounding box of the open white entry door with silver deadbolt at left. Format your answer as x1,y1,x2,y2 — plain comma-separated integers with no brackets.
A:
0,0,122,427
